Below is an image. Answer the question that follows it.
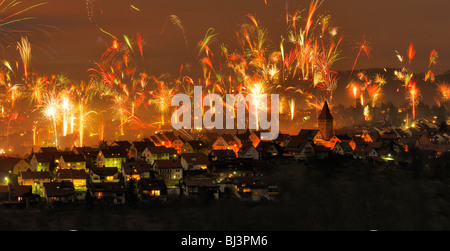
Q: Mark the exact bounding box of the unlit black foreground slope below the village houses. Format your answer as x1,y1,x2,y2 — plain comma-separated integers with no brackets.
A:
0,157,450,231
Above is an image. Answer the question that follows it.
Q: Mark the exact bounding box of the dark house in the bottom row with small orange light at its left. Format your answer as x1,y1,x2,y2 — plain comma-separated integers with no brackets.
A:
89,182,126,205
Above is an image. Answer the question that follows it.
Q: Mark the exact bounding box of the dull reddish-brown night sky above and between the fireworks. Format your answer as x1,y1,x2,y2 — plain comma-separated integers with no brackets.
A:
2,0,450,109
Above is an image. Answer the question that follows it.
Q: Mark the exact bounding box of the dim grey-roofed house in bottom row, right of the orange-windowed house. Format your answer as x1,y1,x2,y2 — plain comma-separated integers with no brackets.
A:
183,178,219,199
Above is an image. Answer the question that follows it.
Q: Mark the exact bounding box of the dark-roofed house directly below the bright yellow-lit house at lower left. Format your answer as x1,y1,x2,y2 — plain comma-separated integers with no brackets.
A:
43,181,75,204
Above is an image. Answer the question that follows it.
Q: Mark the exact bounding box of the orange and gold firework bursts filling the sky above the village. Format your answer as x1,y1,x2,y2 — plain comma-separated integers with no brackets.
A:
0,0,450,153
